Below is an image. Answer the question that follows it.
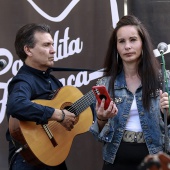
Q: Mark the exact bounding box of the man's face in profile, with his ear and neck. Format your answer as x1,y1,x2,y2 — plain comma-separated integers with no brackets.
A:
25,32,55,71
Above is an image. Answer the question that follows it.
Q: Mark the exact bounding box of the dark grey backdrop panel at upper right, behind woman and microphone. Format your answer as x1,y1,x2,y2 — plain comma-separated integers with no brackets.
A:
127,0,170,70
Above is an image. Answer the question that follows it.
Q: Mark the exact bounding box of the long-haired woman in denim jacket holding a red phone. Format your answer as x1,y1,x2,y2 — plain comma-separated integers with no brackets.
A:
90,15,169,170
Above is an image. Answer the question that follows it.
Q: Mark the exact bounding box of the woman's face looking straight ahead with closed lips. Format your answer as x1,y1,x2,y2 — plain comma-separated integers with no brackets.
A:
117,25,142,64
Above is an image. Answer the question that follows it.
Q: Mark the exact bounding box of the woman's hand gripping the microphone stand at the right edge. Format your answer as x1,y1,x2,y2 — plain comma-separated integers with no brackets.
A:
160,90,169,113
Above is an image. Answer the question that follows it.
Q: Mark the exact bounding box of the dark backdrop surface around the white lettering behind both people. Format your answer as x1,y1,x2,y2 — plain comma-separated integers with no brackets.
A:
0,0,170,170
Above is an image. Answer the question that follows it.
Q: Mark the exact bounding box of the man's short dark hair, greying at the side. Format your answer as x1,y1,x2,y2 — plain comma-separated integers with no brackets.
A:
15,23,51,62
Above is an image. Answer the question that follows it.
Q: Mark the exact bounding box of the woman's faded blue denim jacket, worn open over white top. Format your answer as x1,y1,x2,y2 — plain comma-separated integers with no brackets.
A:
90,71,169,163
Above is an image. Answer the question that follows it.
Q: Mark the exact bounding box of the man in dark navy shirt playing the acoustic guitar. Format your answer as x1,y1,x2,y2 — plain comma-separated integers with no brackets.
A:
6,24,75,170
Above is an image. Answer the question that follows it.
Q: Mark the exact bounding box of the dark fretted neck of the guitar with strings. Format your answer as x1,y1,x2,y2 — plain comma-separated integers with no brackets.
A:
68,90,95,116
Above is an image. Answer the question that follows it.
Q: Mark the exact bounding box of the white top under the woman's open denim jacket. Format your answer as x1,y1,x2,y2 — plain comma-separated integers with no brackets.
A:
125,96,142,132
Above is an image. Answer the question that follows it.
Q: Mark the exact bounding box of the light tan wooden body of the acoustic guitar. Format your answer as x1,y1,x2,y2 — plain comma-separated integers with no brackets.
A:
9,86,93,166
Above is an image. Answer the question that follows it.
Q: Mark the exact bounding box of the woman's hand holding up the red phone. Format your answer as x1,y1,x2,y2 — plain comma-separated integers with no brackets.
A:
96,99,118,121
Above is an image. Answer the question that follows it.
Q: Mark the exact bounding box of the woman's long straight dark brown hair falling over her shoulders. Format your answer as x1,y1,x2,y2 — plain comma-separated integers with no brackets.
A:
104,15,160,110
